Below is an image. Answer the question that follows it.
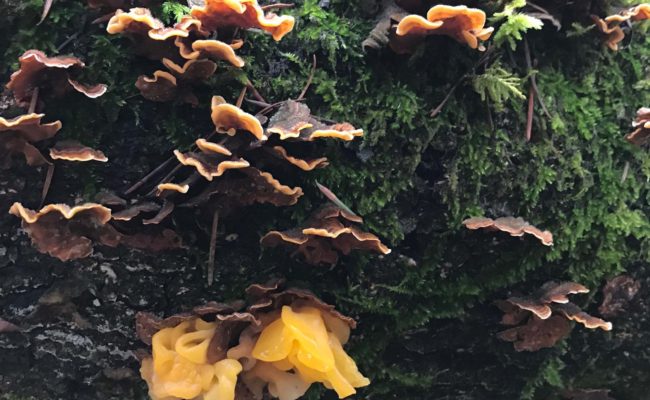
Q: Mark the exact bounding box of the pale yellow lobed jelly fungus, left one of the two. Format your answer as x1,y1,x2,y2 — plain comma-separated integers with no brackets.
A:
140,319,242,400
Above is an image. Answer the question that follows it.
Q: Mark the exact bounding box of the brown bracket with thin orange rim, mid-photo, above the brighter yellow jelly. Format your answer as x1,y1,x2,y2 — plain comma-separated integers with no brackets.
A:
260,204,390,265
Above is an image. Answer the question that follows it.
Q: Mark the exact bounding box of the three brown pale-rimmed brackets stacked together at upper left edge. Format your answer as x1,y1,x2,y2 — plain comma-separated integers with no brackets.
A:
0,50,108,167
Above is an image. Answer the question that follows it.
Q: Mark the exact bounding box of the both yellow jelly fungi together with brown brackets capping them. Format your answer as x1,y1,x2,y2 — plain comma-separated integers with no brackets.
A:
136,282,370,400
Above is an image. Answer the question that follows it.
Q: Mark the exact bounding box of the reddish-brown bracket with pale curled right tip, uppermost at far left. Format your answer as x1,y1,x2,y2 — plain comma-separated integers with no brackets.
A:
7,50,107,107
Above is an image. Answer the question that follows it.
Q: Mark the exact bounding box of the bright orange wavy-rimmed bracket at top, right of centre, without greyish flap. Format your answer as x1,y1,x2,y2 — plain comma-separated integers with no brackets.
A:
395,4,494,50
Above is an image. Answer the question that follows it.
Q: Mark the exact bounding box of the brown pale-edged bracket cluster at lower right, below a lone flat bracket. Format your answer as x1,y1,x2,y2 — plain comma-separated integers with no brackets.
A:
497,282,612,351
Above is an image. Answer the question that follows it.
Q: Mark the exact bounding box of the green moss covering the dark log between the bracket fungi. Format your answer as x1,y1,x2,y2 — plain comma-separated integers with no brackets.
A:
0,0,650,400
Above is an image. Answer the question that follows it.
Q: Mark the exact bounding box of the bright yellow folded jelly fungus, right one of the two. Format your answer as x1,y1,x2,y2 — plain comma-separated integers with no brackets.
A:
251,306,370,399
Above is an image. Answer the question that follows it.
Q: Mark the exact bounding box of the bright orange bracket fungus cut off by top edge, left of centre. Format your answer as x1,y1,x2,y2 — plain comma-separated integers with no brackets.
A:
191,0,295,41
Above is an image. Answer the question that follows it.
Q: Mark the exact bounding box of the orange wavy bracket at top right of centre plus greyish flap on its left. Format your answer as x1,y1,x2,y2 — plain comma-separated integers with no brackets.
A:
363,1,494,54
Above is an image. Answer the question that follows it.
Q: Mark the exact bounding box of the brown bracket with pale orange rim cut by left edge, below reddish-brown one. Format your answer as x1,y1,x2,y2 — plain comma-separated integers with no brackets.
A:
0,113,61,168
